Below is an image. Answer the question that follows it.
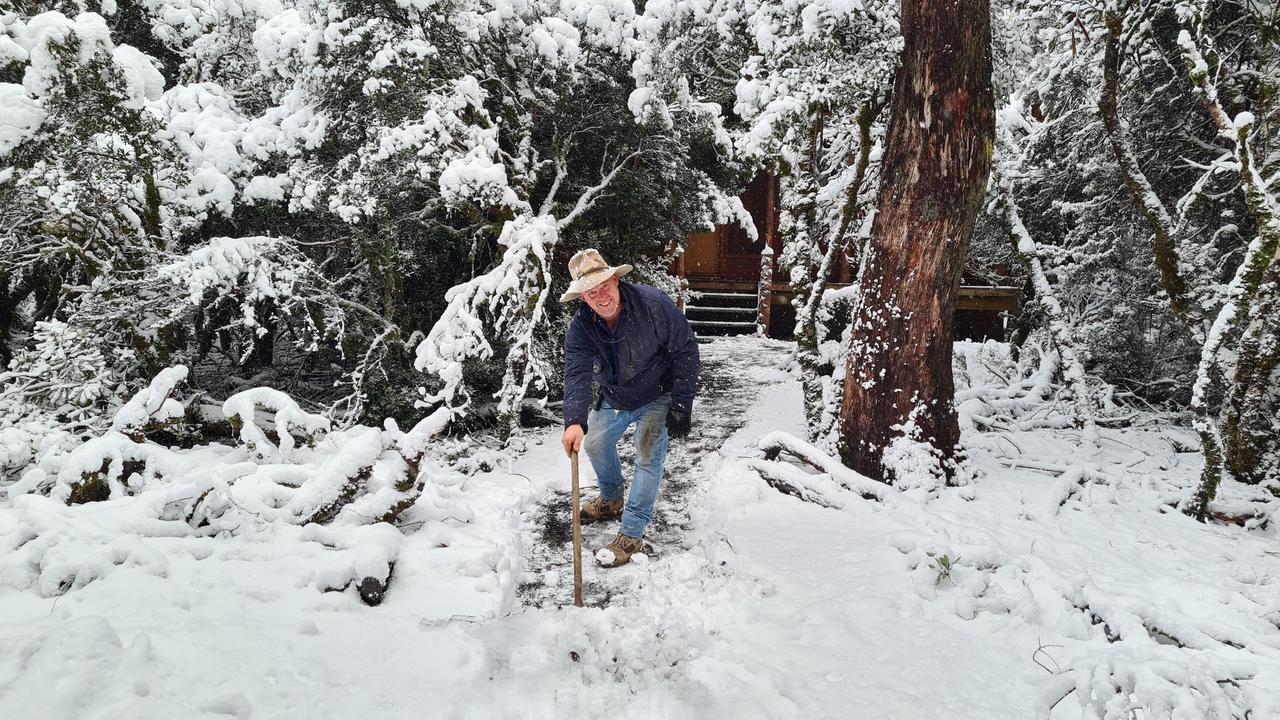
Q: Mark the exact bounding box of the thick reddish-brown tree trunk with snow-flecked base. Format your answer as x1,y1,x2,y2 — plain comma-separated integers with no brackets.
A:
841,0,995,482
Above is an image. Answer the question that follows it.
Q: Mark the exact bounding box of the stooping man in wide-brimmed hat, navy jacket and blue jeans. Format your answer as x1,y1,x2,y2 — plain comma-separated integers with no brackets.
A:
561,249,698,568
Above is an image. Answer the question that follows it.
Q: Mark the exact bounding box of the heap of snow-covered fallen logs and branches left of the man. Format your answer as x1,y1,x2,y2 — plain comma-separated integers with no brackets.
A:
0,366,515,605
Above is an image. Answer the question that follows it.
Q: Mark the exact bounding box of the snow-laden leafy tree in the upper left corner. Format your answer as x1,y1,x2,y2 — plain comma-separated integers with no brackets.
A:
0,12,188,368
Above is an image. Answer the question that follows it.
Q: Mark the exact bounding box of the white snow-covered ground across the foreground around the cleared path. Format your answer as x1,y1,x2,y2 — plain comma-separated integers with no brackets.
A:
0,338,1280,720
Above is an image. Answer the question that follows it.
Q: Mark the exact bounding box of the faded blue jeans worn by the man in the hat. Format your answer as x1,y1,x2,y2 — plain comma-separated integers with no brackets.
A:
582,393,671,538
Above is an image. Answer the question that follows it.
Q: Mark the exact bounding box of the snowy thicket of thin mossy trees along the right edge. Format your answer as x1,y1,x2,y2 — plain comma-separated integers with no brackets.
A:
998,1,1277,504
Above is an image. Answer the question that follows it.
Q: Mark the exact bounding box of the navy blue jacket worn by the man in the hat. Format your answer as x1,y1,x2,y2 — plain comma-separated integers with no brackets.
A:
564,282,698,430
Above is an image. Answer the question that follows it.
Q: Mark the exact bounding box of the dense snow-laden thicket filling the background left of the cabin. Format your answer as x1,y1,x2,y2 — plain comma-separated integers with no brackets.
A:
0,0,740,430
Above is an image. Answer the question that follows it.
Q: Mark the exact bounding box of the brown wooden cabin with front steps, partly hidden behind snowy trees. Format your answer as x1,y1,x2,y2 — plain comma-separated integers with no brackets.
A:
672,173,1020,341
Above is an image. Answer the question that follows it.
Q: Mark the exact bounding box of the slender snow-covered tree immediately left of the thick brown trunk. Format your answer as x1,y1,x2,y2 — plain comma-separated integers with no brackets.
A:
735,3,901,439
